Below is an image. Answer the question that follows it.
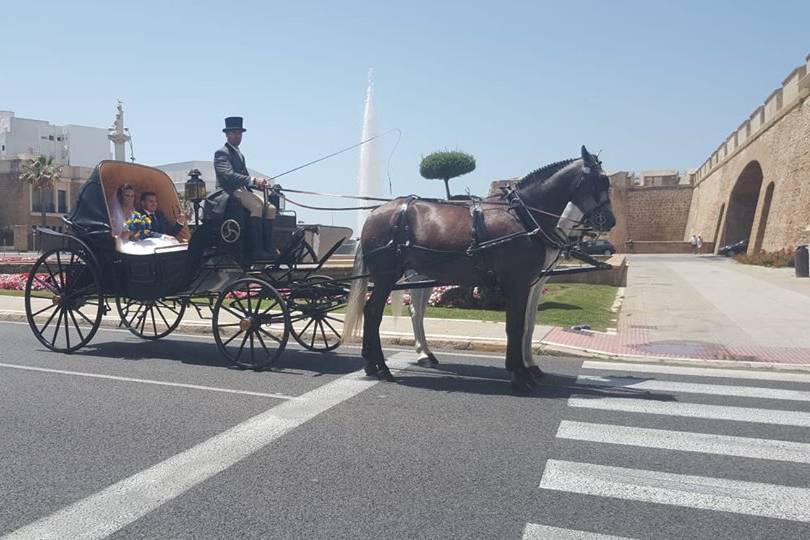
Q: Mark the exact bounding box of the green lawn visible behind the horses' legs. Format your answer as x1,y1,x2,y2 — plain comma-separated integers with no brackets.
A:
385,283,616,330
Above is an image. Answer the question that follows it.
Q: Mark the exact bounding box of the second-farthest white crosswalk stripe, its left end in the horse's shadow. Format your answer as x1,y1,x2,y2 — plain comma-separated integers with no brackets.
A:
576,375,810,401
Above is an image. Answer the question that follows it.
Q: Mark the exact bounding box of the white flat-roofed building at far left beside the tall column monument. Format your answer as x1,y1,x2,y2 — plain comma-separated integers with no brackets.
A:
0,111,112,167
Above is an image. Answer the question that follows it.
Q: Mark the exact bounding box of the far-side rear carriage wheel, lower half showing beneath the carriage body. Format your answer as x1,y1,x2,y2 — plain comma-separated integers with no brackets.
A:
115,297,186,340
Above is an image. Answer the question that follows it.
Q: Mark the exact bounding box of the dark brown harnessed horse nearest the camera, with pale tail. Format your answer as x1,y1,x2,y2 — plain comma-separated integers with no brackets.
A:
343,146,616,392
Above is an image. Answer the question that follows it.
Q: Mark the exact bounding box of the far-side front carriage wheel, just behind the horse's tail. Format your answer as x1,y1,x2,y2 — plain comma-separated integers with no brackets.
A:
289,276,348,352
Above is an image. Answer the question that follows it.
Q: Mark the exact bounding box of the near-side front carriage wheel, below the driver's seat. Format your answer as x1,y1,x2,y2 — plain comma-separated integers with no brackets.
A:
213,277,290,371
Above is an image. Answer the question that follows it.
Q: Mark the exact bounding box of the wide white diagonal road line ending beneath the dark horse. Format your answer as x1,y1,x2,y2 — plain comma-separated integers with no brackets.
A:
4,353,416,540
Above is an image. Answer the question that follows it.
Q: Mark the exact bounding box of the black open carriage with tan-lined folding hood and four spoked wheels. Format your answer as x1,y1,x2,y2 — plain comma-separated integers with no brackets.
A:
25,161,352,370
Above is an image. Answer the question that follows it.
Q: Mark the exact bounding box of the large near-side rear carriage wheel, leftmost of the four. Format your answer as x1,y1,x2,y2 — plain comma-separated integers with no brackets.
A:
25,249,104,353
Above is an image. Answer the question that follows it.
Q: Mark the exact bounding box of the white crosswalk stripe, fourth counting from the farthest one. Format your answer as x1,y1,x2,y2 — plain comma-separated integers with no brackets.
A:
557,420,810,463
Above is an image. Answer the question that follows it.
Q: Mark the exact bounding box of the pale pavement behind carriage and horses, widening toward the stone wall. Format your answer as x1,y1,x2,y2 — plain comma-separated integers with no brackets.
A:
0,255,810,367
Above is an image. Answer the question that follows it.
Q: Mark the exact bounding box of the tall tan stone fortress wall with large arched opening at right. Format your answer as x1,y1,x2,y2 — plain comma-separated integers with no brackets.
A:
684,56,810,253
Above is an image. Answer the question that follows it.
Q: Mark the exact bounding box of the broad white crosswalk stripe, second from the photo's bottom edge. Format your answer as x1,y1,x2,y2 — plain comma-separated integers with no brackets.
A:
540,459,810,522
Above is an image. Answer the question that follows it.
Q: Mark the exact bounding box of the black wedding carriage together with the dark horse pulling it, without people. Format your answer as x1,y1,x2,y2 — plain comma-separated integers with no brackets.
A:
25,146,615,391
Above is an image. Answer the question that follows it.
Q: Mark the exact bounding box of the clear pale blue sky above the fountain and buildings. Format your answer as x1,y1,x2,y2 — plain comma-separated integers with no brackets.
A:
0,0,810,224
